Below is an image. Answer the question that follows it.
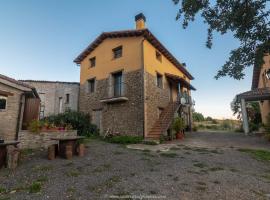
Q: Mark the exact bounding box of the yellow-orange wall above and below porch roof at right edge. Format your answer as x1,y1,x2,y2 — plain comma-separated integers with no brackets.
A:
258,55,270,123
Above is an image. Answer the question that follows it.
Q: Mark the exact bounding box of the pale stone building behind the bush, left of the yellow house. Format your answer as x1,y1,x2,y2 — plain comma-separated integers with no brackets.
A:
22,80,79,118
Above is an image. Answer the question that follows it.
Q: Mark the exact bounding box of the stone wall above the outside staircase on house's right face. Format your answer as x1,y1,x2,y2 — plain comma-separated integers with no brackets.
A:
145,72,170,135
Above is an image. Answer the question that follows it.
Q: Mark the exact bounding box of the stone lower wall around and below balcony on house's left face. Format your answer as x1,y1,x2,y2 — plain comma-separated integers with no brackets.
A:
79,69,144,136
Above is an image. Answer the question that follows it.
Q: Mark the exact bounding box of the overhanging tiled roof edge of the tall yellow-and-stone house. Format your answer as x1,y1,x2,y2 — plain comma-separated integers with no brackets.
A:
74,29,194,80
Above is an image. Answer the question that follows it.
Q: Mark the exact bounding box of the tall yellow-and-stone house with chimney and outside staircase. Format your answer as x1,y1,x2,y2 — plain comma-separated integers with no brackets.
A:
74,14,195,139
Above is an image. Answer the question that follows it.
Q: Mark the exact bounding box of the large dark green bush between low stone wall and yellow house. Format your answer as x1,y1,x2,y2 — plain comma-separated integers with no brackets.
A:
43,110,99,136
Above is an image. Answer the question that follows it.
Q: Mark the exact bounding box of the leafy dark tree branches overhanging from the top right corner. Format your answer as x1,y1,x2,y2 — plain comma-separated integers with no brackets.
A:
173,0,270,80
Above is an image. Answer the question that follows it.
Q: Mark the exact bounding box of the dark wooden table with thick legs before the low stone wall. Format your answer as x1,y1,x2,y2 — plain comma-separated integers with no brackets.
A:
51,136,85,158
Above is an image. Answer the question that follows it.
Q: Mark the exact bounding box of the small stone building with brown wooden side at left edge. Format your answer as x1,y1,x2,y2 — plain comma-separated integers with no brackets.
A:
0,74,40,140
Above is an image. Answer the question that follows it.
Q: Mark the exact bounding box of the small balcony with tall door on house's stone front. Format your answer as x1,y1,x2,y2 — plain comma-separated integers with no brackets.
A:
100,82,128,104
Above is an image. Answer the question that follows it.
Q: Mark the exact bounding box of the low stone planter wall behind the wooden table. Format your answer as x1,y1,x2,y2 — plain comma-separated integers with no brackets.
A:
18,131,77,149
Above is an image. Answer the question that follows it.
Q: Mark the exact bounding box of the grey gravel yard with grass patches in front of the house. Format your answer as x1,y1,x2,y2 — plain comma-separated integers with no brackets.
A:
0,133,270,200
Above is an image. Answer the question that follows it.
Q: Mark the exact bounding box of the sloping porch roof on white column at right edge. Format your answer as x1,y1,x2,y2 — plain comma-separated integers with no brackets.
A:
236,87,270,101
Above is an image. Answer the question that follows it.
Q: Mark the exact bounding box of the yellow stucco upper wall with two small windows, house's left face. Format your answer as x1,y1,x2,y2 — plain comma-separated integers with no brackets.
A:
80,37,143,84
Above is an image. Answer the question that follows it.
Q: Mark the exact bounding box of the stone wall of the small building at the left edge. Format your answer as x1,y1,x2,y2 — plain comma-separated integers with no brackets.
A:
0,83,24,140
